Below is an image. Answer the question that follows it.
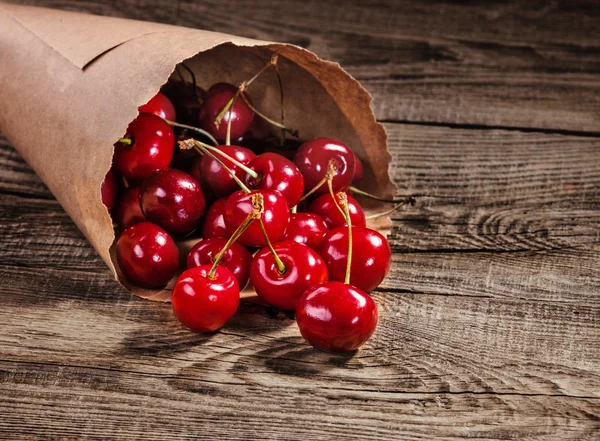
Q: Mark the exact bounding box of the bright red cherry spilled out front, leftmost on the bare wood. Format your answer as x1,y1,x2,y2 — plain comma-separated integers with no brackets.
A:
171,265,240,332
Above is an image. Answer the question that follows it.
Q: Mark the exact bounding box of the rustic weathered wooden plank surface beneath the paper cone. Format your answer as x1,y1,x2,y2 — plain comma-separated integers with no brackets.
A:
0,0,600,440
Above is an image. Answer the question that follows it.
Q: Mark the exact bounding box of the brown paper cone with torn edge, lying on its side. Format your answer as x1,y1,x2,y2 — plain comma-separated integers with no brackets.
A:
0,4,395,301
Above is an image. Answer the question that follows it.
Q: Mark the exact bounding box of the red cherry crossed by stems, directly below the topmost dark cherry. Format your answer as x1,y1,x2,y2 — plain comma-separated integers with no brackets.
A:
199,145,256,197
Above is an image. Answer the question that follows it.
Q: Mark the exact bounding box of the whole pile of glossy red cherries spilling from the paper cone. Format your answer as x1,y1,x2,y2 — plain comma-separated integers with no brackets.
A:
101,59,406,352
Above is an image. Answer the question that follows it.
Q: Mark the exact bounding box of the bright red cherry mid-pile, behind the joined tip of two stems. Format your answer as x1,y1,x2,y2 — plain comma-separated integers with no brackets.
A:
225,190,290,247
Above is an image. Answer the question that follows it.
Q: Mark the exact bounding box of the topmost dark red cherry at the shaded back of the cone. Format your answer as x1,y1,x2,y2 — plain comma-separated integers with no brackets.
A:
200,83,254,141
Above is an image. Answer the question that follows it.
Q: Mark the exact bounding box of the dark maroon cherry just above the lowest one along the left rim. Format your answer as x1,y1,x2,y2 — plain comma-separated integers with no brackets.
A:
140,168,206,236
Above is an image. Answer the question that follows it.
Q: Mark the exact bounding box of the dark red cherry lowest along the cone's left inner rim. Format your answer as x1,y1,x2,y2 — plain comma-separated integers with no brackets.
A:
117,222,179,288
